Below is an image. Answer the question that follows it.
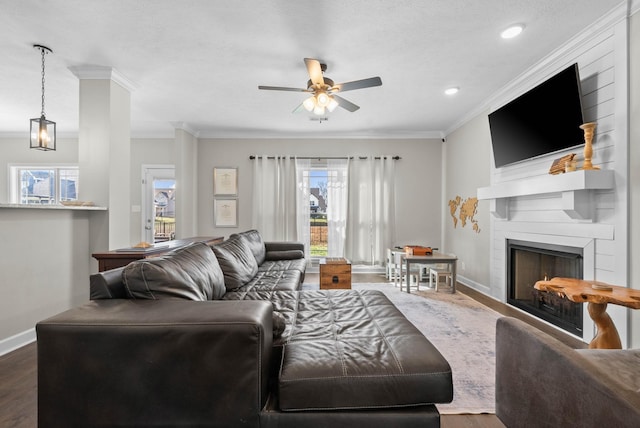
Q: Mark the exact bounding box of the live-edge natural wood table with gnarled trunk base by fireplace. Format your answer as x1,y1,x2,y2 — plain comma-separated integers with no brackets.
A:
534,278,640,349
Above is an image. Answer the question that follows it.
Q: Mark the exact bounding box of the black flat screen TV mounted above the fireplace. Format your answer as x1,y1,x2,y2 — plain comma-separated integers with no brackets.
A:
489,64,584,168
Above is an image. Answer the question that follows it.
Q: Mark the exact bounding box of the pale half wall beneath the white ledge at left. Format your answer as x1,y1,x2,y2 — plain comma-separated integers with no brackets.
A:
0,208,96,354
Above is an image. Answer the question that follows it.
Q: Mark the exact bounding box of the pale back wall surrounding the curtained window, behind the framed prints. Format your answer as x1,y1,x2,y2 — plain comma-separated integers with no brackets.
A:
198,139,442,247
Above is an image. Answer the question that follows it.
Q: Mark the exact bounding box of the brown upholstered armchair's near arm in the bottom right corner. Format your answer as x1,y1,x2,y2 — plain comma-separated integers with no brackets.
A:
496,317,640,427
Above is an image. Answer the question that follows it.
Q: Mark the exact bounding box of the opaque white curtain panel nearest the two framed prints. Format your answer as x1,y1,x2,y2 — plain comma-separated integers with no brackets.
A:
252,156,298,241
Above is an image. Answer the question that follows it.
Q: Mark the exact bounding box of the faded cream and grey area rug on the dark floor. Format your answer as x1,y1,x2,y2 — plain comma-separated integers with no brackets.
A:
304,283,500,414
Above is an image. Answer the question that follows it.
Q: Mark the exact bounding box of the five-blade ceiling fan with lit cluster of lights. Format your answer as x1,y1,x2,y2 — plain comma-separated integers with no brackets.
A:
258,58,382,116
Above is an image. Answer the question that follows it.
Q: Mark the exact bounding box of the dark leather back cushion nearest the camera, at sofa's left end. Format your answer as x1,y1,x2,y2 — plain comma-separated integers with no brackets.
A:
122,242,226,301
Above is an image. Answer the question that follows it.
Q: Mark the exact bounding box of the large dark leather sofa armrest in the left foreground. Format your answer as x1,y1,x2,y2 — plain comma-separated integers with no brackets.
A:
36,299,272,426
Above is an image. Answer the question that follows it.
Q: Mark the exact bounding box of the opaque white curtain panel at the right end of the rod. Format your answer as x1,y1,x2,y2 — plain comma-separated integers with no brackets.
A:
345,156,395,265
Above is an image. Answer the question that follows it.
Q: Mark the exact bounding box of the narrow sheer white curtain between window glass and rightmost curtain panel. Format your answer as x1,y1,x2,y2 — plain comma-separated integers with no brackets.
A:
327,159,349,257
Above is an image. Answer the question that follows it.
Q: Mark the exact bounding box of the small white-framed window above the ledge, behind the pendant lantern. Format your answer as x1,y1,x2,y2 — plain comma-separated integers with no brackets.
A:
10,166,78,205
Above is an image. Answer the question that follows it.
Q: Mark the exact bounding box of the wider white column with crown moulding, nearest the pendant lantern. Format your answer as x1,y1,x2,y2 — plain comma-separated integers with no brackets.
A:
70,67,133,260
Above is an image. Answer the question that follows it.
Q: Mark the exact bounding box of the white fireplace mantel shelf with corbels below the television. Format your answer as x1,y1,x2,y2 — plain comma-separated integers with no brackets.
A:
477,170,614,220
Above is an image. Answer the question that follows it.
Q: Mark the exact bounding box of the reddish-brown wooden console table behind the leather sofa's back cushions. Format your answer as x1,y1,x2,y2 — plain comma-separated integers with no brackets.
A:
91,236,224,272
